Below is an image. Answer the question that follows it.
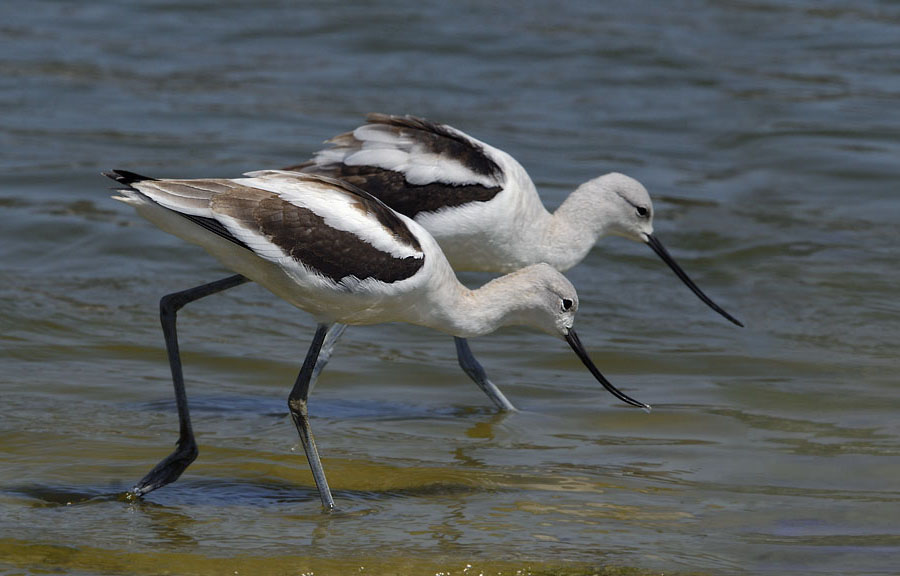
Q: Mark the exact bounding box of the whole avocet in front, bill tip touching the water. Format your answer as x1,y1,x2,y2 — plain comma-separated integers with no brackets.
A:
106,170,649,508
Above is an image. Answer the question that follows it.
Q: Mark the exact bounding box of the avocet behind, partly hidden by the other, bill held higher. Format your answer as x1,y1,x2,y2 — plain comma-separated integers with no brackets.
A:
280,114,743,410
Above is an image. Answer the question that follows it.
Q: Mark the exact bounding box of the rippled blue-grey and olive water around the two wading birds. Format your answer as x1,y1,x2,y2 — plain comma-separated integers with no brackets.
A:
0,0,900,575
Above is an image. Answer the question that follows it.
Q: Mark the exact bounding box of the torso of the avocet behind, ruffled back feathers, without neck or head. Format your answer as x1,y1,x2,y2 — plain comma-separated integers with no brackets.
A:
292,114,550,272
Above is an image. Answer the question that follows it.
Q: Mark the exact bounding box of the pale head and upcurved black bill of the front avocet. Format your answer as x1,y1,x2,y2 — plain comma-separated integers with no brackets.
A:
514,264,650,410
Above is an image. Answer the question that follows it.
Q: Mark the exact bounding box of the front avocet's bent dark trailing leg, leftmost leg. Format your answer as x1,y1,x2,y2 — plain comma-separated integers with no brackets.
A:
131,274,249,496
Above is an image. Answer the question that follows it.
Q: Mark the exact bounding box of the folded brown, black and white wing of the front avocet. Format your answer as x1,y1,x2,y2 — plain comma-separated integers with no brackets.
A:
106,170,424,285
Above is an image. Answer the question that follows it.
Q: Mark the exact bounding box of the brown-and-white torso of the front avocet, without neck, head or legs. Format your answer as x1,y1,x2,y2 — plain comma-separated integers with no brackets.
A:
107,171,442,324
